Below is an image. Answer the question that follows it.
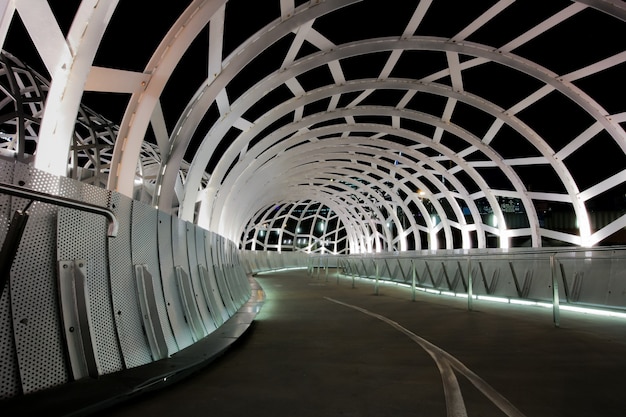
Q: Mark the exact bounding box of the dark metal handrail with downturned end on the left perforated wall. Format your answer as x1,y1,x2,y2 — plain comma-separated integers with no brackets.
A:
0,182,119,237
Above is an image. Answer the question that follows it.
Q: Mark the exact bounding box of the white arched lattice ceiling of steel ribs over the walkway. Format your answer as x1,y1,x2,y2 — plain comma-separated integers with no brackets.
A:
0,0,626,252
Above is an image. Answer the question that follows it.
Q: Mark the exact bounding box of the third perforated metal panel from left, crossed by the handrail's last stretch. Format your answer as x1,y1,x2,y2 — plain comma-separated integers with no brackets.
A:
57,178,123,374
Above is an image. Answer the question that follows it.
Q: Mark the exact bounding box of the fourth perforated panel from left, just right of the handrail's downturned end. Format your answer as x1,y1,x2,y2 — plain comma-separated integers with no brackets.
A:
108,193,152,368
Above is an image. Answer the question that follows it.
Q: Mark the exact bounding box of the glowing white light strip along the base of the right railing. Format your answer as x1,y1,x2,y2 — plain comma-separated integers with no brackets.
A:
342,275,626,320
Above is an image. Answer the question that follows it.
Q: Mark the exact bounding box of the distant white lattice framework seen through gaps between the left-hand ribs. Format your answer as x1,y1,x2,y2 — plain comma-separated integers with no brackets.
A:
0,52,208,203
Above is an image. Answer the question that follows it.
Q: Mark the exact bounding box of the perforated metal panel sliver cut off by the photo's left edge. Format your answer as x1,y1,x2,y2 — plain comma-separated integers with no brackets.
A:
0,160,20,398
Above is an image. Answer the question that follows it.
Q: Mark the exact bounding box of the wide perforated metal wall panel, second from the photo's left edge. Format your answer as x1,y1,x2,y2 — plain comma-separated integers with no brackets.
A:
11,165,69,394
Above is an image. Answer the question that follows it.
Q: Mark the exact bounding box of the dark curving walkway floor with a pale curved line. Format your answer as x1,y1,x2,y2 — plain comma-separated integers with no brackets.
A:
99,270,626,417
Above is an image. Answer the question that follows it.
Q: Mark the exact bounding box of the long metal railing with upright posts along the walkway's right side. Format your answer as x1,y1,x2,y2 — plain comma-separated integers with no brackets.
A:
308,246,626,327
